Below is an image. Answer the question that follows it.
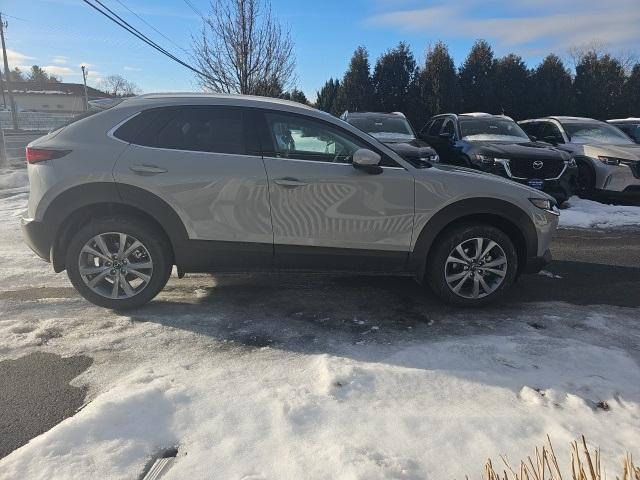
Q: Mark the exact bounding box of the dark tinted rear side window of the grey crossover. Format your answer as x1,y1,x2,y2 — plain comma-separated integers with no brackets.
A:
120,106,247,155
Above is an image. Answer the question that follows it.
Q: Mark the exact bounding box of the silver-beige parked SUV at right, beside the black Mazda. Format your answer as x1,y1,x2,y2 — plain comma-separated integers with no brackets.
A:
520,117,640,196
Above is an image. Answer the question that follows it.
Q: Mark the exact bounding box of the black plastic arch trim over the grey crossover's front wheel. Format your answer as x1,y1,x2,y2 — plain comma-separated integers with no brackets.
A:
409,197,538,279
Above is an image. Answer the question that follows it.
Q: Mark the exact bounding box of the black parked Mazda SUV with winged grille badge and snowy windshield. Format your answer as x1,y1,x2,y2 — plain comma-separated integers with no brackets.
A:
420,113,578,203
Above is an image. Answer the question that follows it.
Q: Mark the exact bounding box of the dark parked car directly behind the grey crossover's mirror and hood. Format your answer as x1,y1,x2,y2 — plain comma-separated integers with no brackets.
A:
340,111,439,167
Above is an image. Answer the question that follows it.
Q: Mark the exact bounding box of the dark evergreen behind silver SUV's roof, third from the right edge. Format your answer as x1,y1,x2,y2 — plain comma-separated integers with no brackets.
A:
528,54,573,117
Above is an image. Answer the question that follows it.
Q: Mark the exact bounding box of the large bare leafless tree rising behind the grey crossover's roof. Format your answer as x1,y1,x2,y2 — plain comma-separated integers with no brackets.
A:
192,0,296,96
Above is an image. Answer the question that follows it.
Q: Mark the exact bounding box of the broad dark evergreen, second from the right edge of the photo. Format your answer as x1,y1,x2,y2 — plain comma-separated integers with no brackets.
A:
573,52,625,120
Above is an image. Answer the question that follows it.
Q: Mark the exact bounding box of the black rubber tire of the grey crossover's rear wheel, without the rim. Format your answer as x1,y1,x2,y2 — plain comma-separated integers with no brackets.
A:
65,216,173,310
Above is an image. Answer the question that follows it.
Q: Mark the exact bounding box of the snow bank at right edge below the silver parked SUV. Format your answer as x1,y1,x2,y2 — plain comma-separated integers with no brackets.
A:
560,197,640,229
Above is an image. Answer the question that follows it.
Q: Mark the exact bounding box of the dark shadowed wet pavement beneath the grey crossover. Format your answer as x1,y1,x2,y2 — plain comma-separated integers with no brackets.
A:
125,262,640,353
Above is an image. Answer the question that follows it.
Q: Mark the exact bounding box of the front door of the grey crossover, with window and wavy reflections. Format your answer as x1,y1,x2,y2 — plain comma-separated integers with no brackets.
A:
261,111,414,271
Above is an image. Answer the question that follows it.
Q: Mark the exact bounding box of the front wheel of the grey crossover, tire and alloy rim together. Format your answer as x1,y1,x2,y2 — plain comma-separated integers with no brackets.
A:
426,224,518,306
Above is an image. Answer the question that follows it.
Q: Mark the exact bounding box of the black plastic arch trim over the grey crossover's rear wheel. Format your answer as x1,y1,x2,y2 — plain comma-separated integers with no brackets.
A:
42,182,188,272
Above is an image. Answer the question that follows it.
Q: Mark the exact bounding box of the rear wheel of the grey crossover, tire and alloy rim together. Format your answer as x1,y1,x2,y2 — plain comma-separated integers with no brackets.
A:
66,217,172,310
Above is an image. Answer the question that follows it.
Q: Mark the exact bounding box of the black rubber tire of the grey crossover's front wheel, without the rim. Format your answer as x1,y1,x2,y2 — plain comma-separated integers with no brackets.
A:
426,223,518,307
